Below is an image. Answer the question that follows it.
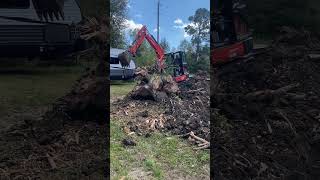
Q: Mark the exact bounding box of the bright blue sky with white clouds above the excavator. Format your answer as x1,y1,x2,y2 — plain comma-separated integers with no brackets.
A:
127,0,210,48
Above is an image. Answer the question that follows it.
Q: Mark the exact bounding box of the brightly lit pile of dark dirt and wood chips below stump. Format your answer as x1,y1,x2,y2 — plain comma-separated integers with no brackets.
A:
112,72,210,148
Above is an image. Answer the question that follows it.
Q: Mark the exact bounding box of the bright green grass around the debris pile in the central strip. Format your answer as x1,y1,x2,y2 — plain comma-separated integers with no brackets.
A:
110,82,210,180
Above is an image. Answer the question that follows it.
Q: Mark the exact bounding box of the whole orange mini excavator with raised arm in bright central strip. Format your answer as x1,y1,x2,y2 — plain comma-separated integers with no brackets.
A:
129,26,188,82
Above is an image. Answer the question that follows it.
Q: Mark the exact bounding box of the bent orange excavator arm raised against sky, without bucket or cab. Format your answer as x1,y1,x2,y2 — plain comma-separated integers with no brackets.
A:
129,26,165,71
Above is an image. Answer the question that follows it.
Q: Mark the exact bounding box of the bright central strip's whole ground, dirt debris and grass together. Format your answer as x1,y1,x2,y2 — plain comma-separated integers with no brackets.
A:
111,73,210,179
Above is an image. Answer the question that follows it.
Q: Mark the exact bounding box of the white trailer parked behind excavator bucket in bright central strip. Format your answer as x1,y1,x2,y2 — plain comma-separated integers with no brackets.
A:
110,48,136,80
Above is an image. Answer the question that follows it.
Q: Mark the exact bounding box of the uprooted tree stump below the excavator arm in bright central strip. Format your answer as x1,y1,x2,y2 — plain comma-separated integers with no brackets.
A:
130,69,179,101
